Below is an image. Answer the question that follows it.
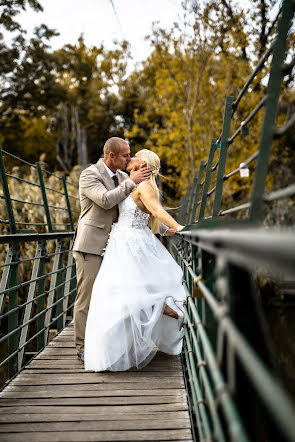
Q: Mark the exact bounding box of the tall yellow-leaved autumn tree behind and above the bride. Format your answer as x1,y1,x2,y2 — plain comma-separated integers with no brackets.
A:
123,1,251,202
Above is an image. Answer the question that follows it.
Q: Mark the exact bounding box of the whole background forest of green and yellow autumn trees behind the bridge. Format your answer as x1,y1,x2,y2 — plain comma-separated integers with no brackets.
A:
0,0,295,211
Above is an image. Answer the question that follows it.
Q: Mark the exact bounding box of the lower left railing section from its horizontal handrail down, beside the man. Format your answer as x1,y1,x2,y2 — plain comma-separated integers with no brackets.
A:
0,232,76,384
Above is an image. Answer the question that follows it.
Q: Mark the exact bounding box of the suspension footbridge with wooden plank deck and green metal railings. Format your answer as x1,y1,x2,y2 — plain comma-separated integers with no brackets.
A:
0,0,295,442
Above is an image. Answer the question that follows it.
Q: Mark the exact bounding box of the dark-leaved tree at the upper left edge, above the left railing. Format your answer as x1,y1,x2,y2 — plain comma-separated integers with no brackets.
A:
0,0,66,160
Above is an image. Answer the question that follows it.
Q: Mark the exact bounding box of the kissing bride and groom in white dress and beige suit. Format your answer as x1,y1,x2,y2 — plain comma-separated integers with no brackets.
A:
73,137,186,371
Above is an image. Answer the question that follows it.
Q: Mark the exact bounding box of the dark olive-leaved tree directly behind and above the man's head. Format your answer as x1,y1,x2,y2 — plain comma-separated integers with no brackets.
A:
51,36,129,168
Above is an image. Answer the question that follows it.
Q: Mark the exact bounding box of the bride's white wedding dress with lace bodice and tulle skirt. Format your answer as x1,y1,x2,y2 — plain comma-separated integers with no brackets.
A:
84,195,186,371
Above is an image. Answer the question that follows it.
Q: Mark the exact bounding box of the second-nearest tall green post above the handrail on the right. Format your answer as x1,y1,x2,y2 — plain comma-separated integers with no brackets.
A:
212,96,234,218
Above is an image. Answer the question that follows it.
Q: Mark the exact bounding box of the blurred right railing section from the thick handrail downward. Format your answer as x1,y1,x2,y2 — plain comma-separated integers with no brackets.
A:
171,226,295,441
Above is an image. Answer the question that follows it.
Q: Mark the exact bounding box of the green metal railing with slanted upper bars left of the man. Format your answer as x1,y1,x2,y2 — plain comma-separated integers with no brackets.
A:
0,150,79,385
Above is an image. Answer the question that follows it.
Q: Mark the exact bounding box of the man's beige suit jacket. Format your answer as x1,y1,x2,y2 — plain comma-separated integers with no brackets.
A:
73,159,136,255
